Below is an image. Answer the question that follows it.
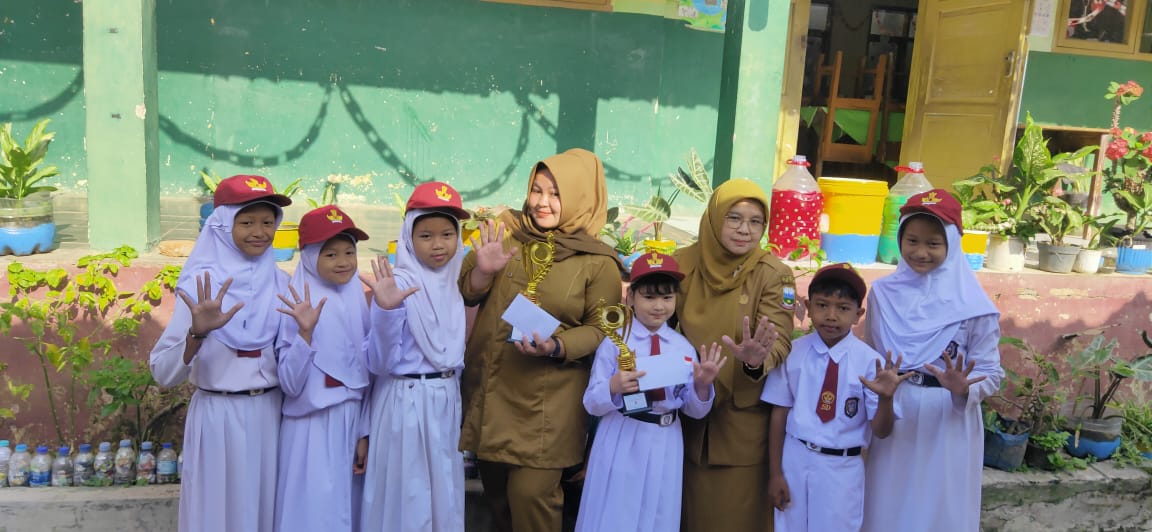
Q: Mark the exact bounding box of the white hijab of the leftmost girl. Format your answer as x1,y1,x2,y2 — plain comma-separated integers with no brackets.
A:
176,200,288,351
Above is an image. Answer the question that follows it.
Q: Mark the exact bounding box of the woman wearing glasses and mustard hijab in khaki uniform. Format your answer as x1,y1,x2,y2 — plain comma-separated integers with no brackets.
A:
675,180,796,532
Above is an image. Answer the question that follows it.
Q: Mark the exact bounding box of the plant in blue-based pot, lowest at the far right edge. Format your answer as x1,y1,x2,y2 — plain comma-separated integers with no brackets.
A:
1068,333,1152,459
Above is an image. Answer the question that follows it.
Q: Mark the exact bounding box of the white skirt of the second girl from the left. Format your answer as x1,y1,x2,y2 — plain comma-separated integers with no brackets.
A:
276,401,361,532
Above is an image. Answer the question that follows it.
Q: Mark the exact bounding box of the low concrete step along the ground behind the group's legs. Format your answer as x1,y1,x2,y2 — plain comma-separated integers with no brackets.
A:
0,462,1152,532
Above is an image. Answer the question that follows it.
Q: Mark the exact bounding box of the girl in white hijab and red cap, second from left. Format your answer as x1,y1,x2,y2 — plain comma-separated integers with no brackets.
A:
275,205,370,532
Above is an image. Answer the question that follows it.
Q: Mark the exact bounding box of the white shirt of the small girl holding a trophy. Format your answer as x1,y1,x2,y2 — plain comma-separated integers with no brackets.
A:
584,318,715,419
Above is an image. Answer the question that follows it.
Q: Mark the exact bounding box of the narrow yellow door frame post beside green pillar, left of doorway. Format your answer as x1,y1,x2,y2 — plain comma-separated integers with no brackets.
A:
772,0,812,176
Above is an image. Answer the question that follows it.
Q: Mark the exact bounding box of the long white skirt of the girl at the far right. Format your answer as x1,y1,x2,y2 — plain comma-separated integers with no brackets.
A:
863,382,984,532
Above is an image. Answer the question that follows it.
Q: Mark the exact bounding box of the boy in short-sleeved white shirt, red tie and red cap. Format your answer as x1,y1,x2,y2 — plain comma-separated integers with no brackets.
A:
760,263,907,532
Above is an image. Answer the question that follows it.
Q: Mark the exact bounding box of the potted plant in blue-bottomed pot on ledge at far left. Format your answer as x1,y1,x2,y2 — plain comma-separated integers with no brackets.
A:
0,119,60,256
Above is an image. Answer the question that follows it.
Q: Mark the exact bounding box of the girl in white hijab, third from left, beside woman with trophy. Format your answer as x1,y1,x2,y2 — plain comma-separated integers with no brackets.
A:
361,182,469,532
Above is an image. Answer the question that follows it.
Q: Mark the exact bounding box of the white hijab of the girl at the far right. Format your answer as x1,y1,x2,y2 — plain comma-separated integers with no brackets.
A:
867,213,1000,370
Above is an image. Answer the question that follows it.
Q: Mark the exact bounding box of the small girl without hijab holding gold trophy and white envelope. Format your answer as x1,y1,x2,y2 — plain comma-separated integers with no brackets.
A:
576,251,727,532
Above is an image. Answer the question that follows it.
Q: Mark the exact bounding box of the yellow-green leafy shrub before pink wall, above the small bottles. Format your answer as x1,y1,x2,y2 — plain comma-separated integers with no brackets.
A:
0,245,180,441
